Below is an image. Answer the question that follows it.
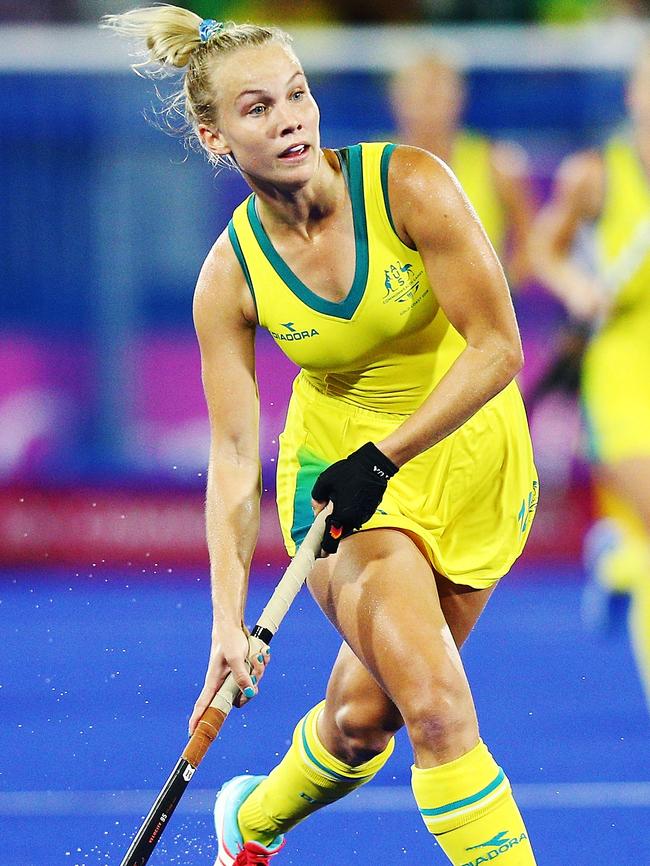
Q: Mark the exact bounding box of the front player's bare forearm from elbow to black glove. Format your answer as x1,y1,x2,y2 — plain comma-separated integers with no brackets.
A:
375,345,522,466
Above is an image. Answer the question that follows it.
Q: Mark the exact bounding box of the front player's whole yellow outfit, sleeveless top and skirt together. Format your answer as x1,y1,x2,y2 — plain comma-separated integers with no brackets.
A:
228,144,538,587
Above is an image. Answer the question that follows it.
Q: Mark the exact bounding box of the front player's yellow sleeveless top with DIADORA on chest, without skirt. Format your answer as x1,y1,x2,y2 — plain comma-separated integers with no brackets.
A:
228,143,465,414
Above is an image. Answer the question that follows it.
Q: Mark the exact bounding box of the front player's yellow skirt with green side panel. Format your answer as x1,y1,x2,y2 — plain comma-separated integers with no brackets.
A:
277,374,539,589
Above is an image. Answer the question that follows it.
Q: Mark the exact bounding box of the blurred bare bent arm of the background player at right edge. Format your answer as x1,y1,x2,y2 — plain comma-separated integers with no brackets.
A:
530,152,604,321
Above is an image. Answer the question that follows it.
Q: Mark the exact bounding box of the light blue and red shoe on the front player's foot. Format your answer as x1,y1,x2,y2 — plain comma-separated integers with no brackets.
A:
214,776,284,866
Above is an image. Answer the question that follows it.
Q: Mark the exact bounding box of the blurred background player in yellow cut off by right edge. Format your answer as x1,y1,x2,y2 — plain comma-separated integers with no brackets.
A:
531,45,650,712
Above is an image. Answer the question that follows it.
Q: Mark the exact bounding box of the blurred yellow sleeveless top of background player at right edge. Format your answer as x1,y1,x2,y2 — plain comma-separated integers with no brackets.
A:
596,135,650,333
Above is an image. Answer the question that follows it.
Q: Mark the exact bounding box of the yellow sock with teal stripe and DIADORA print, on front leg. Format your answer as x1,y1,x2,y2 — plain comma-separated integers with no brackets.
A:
412,740,535,866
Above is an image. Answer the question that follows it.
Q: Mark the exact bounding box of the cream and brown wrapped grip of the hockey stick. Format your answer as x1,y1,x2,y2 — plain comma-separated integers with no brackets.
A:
182,509,329,768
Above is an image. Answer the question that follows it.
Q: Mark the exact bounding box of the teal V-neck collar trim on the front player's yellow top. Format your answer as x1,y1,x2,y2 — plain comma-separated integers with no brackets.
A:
246,144,368,319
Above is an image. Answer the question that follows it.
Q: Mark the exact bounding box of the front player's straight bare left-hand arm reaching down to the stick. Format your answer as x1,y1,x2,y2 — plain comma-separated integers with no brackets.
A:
190,234,261,731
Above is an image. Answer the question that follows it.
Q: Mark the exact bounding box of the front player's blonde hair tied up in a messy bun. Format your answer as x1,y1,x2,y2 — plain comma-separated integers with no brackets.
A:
100,3,293,163
